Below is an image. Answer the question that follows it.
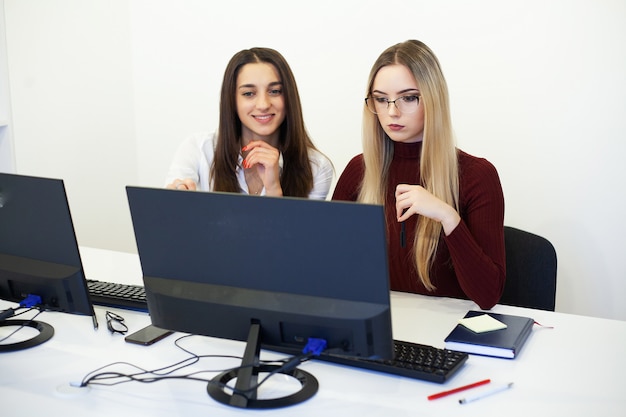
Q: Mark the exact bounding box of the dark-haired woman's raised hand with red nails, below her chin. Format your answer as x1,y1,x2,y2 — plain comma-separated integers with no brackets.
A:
241,140,283,196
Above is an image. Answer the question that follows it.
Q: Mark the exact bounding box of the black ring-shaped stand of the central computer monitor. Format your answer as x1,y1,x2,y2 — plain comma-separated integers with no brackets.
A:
207,323,319,409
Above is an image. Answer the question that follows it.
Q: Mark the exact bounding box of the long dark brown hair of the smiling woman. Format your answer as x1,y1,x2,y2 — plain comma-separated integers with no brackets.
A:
211,48,315,197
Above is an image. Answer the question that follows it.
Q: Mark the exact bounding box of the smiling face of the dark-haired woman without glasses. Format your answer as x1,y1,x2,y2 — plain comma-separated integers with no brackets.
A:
235,63,285,146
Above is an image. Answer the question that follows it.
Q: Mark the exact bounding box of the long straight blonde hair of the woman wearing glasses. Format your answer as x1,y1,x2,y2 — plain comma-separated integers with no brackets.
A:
359,40,459,291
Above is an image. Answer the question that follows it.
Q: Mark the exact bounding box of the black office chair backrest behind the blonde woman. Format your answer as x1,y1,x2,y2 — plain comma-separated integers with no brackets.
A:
500,226,557,311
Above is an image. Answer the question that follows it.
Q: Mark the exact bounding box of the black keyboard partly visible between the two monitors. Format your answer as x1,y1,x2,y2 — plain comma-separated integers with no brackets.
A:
87,279,148,311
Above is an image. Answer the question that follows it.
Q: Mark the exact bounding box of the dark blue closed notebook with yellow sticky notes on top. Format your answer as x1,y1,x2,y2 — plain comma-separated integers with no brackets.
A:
445,311,535,359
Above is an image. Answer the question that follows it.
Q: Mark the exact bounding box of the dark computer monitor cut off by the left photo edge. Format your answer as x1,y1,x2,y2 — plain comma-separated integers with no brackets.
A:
0,173,97,348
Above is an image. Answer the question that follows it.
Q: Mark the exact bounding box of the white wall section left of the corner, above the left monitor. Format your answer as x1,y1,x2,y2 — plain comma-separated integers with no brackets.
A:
5,0,137,250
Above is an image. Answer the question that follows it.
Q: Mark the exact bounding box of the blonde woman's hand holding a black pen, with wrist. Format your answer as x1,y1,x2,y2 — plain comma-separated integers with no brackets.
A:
396,184,461,236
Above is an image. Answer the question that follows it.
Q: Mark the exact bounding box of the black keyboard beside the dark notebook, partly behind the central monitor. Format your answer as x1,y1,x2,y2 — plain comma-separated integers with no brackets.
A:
316,340,469,383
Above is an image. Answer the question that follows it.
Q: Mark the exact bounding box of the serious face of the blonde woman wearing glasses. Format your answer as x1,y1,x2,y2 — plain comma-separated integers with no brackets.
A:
370,64,424,143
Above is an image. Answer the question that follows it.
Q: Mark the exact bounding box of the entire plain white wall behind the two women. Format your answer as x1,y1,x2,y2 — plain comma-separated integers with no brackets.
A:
5,0,626,320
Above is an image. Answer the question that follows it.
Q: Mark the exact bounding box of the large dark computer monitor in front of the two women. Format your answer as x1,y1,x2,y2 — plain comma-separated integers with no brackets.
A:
126,186,393,407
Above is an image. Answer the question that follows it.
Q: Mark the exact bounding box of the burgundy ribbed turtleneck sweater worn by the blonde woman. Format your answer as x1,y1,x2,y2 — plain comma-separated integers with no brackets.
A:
333,142,506,309
